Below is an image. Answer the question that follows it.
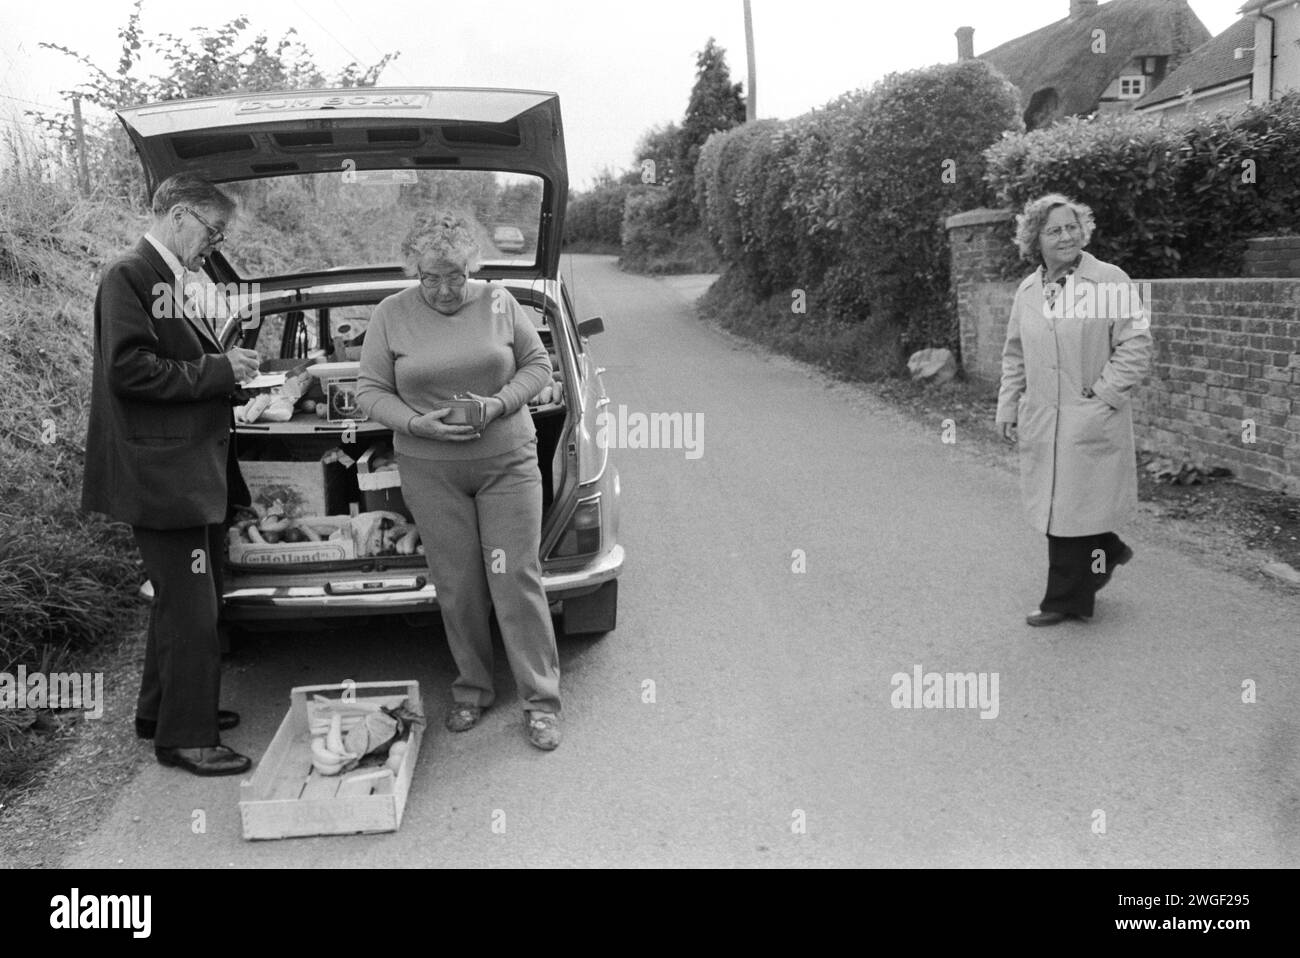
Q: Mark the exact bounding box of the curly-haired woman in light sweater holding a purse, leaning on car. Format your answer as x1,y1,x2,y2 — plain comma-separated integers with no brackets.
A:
358,216,560,750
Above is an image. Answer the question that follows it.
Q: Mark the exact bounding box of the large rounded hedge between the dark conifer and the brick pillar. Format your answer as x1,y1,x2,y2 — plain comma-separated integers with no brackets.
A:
696,61,1021,351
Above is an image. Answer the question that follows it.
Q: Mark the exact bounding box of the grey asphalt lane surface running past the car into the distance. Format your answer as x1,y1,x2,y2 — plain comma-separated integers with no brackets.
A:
65,257,1300,867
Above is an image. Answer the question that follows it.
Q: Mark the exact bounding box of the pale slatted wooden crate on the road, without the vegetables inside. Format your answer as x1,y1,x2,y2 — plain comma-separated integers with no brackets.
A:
239,681,424,838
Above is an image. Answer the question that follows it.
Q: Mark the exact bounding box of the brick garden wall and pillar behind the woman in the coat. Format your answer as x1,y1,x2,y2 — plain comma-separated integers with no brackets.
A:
948,211,1300,494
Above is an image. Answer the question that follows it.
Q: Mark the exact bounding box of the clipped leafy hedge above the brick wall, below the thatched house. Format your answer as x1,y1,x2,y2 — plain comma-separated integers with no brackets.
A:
987,94,1300,279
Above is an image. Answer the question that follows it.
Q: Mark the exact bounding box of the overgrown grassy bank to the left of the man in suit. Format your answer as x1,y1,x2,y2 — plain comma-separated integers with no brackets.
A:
0,170,142,805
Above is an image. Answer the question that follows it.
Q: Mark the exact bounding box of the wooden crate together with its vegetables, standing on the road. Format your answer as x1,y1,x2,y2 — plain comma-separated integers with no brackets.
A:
239,681,424,840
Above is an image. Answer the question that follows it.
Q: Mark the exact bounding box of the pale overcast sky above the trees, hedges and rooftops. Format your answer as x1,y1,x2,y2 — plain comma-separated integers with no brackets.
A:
0,0,1244,187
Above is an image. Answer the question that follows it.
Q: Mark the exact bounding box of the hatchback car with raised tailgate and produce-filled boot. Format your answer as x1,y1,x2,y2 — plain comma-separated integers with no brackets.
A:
118,88,623,634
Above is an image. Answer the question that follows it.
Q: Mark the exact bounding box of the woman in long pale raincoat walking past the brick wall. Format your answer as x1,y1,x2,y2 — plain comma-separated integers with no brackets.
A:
997,194,1152,625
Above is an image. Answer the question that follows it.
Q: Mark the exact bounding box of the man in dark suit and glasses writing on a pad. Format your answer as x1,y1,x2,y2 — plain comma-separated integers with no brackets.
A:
82,174,257,775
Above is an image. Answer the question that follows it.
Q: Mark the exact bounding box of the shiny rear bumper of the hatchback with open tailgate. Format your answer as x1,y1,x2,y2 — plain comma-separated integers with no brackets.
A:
224,546,623,621
